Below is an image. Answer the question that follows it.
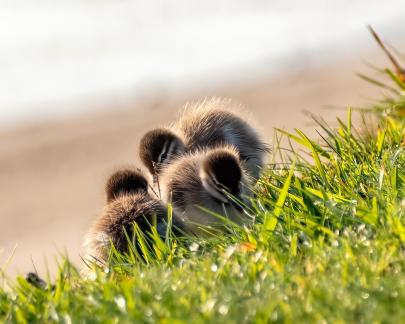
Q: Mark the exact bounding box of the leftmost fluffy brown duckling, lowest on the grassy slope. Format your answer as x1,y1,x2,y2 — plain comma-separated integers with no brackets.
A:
82,169,181,265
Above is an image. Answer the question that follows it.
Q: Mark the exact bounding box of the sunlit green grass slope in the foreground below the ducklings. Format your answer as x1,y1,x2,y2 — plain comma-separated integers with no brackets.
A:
0,67,405,323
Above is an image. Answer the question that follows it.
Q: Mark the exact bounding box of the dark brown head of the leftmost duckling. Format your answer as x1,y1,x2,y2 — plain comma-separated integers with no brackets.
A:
106,169,148,202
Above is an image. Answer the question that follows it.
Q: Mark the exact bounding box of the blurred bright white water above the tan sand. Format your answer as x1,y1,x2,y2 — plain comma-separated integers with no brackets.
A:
0,0,405,124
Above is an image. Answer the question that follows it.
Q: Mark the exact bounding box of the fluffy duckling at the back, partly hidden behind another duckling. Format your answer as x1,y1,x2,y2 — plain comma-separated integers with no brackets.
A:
139,98,269,180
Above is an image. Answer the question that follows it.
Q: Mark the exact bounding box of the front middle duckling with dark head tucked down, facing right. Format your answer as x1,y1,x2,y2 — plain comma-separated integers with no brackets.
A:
159,145,251,236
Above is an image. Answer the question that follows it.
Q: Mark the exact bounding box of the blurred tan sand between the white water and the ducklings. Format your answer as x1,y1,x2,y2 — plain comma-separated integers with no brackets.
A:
0,53,390,275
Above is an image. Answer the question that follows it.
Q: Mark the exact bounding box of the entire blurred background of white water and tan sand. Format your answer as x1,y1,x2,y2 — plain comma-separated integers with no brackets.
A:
0,0,405,275
